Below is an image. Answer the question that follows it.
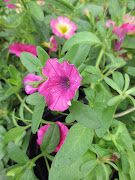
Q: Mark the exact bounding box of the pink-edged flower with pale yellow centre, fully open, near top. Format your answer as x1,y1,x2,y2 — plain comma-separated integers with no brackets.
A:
51,17,77,39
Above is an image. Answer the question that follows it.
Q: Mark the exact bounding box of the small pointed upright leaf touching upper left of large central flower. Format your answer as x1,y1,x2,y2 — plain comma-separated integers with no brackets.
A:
37,46,50,67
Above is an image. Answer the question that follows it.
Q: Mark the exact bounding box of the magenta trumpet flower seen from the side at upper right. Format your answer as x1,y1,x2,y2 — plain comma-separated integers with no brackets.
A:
105,20,135,52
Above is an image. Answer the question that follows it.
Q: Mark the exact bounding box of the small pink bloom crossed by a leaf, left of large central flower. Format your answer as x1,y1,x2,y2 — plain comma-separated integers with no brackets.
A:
23,74,44,94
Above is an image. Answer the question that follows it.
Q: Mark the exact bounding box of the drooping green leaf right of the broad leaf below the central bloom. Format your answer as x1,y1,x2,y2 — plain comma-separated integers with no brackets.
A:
96,106,116,138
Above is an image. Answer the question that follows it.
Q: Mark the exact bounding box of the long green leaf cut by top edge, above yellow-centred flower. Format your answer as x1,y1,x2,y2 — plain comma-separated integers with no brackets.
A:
44,0,75,14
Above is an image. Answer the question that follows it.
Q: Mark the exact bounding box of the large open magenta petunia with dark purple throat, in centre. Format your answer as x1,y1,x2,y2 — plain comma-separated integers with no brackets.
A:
38,58,82,111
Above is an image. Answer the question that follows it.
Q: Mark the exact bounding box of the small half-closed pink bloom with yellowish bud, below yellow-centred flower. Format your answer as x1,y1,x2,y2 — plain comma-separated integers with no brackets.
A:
42,36,58,56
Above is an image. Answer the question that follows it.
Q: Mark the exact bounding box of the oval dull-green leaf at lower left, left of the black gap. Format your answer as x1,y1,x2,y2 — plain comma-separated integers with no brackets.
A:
8,142,29,164
